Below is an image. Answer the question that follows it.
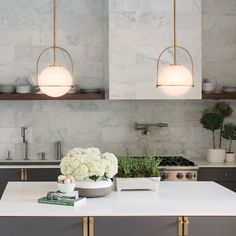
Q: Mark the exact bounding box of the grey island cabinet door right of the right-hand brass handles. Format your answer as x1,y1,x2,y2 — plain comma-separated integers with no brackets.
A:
189,217,236,236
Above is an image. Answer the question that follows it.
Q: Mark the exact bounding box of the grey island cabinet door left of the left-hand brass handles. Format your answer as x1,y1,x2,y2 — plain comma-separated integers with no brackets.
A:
0,217,83,236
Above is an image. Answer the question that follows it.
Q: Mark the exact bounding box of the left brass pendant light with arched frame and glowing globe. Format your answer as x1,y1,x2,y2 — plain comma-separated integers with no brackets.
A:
36,0,73,97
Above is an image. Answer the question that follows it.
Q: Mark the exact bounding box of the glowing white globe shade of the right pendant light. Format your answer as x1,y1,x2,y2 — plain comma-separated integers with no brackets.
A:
158,65,193,96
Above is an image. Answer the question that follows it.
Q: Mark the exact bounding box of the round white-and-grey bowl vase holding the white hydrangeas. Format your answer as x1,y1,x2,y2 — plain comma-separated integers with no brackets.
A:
76,179,113,197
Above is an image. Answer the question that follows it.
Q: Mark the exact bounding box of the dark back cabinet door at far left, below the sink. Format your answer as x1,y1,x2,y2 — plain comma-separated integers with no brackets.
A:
0,169,21,198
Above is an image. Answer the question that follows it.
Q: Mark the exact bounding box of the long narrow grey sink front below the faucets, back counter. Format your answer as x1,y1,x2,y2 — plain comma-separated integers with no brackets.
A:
0,160,61,166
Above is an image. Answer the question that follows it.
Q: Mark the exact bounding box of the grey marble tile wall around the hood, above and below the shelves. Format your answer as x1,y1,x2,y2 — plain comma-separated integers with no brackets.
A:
0,0,236,159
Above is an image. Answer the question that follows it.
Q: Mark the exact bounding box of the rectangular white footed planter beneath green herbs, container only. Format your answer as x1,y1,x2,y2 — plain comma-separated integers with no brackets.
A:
114,177,161,191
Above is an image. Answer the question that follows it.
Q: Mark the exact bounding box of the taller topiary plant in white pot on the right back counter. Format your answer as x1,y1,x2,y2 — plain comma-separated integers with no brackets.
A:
200,102,233,162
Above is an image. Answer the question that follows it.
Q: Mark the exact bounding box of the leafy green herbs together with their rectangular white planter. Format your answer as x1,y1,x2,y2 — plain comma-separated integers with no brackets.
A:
114,156,161,191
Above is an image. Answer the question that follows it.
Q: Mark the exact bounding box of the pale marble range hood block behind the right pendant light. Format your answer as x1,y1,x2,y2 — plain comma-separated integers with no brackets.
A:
107,0,202,100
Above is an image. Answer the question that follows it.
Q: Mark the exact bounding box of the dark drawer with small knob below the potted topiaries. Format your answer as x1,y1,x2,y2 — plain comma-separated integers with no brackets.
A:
198,168,236,182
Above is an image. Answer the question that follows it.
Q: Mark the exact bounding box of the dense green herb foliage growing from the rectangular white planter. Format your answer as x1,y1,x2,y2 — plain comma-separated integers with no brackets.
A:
117,156,160,177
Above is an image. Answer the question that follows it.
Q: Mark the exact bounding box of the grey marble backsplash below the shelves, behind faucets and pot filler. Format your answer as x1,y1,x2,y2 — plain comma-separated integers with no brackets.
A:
0,101,236,159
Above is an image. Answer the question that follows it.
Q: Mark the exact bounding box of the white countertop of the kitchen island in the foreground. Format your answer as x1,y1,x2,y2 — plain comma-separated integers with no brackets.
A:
0,182,236,216
